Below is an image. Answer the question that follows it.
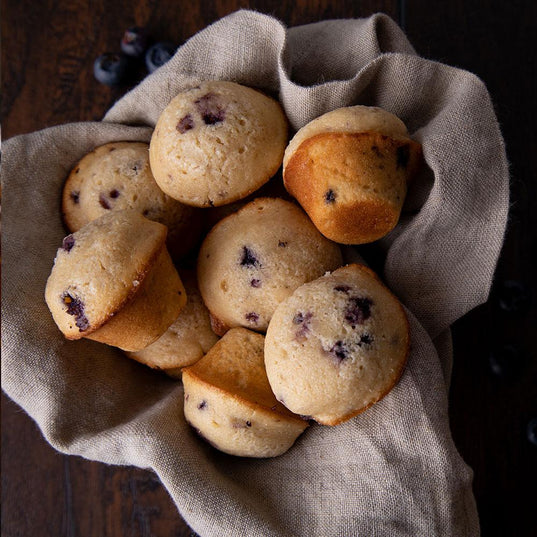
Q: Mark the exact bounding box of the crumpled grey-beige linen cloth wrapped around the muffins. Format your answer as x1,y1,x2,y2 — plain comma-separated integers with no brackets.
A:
2,11,509,537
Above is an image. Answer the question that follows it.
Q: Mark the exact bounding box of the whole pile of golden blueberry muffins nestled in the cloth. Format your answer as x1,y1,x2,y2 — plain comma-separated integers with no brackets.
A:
45,81,421,457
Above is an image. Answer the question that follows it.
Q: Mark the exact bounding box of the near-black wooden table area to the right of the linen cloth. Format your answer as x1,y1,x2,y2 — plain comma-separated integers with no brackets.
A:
406,0,537,537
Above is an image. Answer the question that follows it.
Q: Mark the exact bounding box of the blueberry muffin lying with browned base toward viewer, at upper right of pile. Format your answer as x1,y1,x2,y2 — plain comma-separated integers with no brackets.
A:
283,106,421,244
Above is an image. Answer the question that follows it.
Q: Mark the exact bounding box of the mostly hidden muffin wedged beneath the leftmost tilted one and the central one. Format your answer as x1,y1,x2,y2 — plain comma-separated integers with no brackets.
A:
127,271,218,378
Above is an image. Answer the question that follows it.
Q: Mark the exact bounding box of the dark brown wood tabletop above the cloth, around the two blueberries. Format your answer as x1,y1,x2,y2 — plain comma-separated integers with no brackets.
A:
2,0,397,138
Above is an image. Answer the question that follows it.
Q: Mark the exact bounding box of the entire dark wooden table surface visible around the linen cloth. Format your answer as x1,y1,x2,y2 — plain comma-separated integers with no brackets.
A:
1,0,537,537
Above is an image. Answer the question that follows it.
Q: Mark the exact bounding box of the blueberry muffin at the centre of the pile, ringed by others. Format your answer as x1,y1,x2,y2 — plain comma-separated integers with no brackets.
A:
198,198,342,335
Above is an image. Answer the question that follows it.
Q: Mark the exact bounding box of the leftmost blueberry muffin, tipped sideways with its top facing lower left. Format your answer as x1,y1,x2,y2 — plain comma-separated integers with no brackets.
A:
45,210,186,351
